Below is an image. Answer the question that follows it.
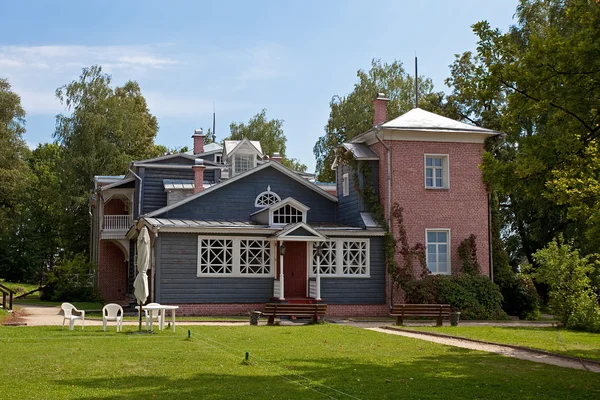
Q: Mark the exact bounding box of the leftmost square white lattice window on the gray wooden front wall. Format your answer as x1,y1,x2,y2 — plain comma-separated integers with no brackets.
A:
198,238,233,275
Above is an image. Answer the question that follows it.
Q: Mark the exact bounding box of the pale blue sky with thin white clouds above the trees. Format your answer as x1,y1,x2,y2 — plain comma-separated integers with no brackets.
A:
0,0,518,171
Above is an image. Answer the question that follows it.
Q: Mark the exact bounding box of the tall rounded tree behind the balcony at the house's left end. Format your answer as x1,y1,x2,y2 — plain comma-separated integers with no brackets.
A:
54,66,158,253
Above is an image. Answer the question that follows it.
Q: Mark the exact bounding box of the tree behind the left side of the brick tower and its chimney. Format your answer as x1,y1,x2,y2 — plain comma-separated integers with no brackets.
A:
313,59,433,182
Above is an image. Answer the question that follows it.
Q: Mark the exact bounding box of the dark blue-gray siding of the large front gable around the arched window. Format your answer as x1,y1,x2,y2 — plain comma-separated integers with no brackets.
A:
158,167,336,223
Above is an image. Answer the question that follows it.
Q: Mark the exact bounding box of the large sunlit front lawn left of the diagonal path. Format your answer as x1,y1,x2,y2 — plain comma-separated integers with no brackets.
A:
0,324,600,400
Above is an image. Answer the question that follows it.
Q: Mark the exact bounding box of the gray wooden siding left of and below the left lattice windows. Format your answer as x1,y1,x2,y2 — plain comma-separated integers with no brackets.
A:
156,233,274,304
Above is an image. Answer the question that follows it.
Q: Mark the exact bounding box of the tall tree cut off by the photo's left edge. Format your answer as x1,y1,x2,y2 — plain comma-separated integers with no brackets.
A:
0,79,31,281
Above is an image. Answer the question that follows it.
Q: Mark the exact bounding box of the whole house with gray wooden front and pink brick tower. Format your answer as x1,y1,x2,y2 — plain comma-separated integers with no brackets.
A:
92,97,497,315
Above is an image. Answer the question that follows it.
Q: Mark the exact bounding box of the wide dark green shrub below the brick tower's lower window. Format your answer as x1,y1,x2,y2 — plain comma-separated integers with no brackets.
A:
404,275,506,319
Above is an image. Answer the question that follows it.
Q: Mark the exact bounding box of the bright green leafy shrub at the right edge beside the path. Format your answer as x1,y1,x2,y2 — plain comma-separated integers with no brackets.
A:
532,237,600,332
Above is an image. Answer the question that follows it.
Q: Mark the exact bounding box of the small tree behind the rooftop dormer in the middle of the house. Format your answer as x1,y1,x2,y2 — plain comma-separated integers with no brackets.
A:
226,109,306,172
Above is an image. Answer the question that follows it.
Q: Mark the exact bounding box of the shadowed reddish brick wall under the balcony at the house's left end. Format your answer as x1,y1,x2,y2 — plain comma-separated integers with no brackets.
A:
98,240,128,302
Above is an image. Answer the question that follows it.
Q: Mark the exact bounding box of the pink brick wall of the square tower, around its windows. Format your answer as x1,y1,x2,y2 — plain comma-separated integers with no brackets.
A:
371,141,489,290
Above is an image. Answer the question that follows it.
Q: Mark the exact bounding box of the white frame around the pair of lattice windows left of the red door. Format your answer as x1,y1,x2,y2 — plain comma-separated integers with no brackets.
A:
196,235,277,278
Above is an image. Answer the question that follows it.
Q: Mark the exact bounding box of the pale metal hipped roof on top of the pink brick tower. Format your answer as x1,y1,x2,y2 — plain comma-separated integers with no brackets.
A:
381,108,500,135
